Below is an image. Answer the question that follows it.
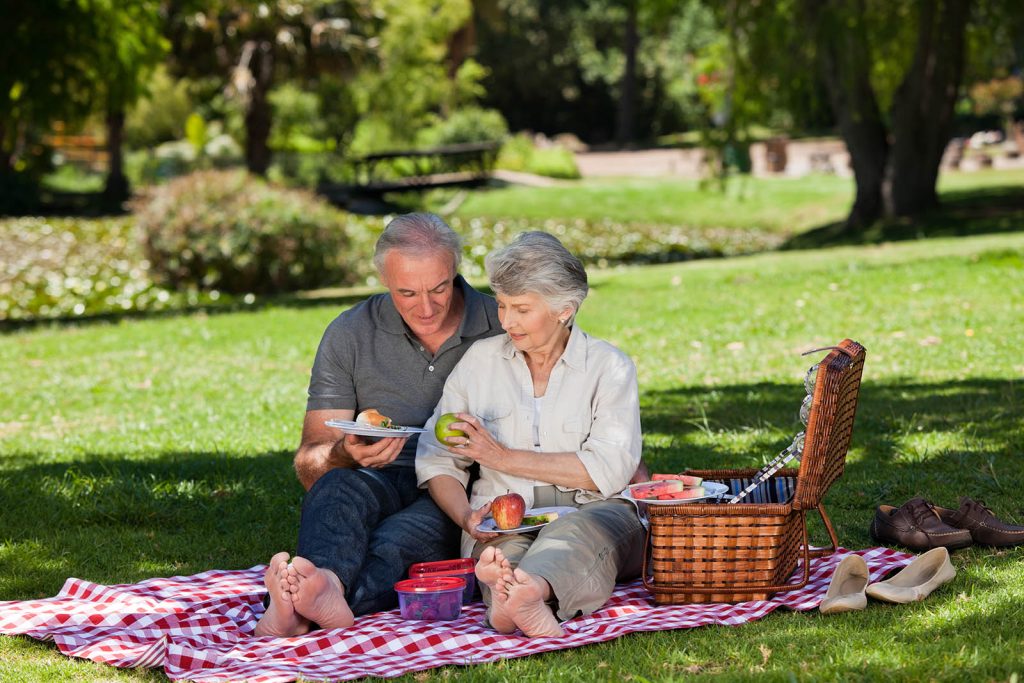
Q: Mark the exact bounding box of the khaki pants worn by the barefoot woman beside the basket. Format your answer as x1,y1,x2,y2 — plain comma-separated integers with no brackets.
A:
473,499,646,621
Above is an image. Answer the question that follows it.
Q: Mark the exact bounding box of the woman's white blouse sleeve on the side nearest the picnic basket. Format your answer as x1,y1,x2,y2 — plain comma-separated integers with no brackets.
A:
577,353,642,497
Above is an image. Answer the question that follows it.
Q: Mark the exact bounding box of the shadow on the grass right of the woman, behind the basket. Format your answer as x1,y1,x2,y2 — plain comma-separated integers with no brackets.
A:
641,376,1024,548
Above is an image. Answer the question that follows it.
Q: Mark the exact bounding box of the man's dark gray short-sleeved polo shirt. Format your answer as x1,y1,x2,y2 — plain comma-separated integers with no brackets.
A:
306,275,503,467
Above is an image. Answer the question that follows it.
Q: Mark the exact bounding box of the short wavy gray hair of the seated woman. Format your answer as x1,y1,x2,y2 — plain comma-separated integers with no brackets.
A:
484,230,590,325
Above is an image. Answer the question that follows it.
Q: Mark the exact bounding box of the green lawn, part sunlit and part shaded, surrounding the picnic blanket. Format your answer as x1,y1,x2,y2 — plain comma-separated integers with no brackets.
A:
0,227,1024,683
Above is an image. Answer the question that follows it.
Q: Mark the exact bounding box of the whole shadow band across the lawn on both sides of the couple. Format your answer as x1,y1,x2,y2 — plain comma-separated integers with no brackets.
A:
0,376,1024,600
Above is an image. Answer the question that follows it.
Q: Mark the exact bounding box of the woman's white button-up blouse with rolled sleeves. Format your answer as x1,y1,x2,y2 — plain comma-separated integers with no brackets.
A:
416,327,641,540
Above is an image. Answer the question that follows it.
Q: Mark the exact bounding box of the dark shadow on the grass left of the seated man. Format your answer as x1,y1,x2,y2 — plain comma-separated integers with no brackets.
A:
0,452,303,600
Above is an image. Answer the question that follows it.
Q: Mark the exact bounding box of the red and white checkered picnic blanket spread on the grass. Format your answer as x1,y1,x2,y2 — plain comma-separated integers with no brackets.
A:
0,548,913,683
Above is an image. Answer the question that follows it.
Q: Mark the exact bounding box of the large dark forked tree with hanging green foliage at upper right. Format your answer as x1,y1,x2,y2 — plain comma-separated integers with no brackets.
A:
716,0,1020,229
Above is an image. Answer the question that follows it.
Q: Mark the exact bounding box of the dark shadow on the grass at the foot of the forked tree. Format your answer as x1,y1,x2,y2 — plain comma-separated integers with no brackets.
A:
780,180,1024,250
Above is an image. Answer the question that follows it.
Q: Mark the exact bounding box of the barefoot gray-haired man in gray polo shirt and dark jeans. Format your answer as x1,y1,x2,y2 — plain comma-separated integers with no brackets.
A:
256,214,502,636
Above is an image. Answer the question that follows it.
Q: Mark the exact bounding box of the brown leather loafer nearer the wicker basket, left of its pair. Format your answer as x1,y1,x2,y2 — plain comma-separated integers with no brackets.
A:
871,498,972,551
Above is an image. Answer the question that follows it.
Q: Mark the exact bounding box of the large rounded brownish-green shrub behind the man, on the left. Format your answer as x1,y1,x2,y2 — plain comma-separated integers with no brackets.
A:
138,171,353,294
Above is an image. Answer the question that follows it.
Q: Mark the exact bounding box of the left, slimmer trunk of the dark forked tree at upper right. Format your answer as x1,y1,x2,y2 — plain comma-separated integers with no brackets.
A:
803,0,889,232
